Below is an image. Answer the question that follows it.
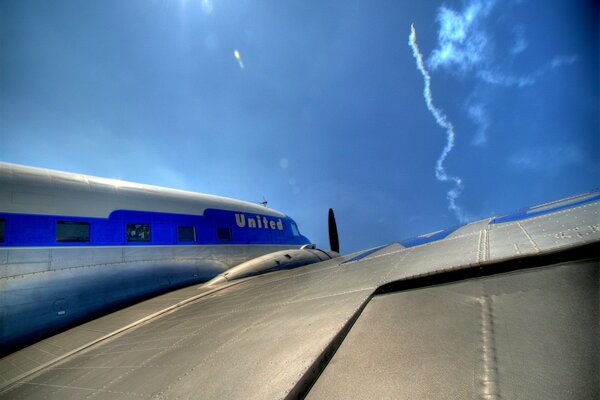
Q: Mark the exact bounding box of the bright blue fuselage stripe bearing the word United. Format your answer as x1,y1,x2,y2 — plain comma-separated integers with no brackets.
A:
0,209,309,247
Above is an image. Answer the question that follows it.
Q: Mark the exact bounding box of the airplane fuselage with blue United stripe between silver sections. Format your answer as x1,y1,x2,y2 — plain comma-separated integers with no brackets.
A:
0,163,308,353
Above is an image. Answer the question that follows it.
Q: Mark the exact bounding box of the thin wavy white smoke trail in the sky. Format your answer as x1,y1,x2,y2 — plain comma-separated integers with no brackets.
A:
408,24,468,223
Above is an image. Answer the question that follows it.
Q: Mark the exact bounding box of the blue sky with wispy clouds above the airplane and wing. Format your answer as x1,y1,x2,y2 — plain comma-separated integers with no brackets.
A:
0,0,600,252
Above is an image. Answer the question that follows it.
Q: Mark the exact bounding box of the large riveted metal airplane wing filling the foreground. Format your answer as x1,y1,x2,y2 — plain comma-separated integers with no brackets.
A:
0,193,600,399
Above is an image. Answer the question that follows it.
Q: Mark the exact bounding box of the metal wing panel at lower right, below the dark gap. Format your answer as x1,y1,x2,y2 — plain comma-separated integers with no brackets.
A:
308,261,599,399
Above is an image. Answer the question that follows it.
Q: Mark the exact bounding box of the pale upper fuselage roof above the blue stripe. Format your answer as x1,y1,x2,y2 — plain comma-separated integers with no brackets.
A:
0,162,284,218
